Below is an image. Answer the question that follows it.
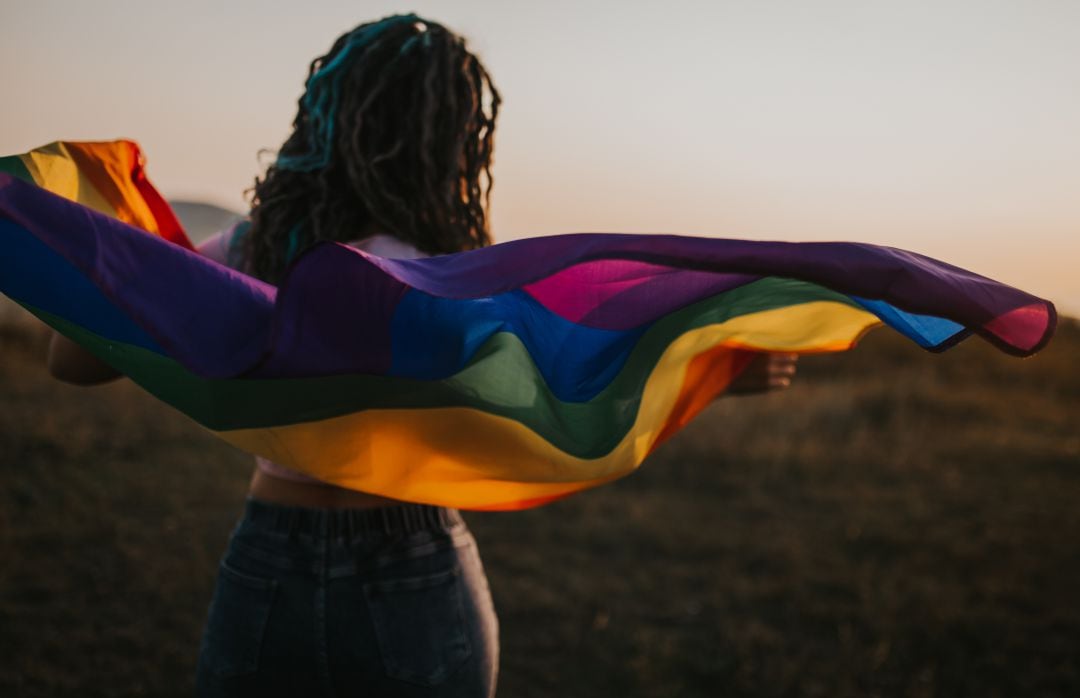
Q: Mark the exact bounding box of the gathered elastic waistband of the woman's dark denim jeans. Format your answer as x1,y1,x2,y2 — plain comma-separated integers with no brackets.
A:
244,498,462,539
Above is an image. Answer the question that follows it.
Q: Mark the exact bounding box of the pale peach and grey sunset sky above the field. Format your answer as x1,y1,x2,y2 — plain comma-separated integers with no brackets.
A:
0,0,1080,316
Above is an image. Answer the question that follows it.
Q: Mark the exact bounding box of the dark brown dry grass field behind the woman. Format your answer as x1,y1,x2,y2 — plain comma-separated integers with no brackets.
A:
0,322,1080,698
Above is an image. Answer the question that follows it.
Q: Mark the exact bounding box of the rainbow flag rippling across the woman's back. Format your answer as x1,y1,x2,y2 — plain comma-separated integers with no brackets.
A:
0,144,1055,509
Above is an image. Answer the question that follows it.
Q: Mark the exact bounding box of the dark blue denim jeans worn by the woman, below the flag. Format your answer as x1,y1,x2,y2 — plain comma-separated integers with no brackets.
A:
195,499,499,697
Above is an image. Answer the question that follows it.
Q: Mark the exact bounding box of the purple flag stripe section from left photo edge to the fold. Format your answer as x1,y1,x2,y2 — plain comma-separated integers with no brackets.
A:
0,174,276,377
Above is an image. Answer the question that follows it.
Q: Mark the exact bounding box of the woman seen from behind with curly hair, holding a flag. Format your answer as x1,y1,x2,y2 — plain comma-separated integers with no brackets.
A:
49,15,794,696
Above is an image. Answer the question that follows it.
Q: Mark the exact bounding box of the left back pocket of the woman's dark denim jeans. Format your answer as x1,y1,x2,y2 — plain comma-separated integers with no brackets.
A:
199,562,278,679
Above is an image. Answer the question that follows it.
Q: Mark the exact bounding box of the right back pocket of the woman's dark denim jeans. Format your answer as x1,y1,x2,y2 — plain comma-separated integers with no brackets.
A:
364,566,472,687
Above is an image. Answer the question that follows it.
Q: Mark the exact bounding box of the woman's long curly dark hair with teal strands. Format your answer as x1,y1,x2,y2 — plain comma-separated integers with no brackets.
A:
237,14,500,282
